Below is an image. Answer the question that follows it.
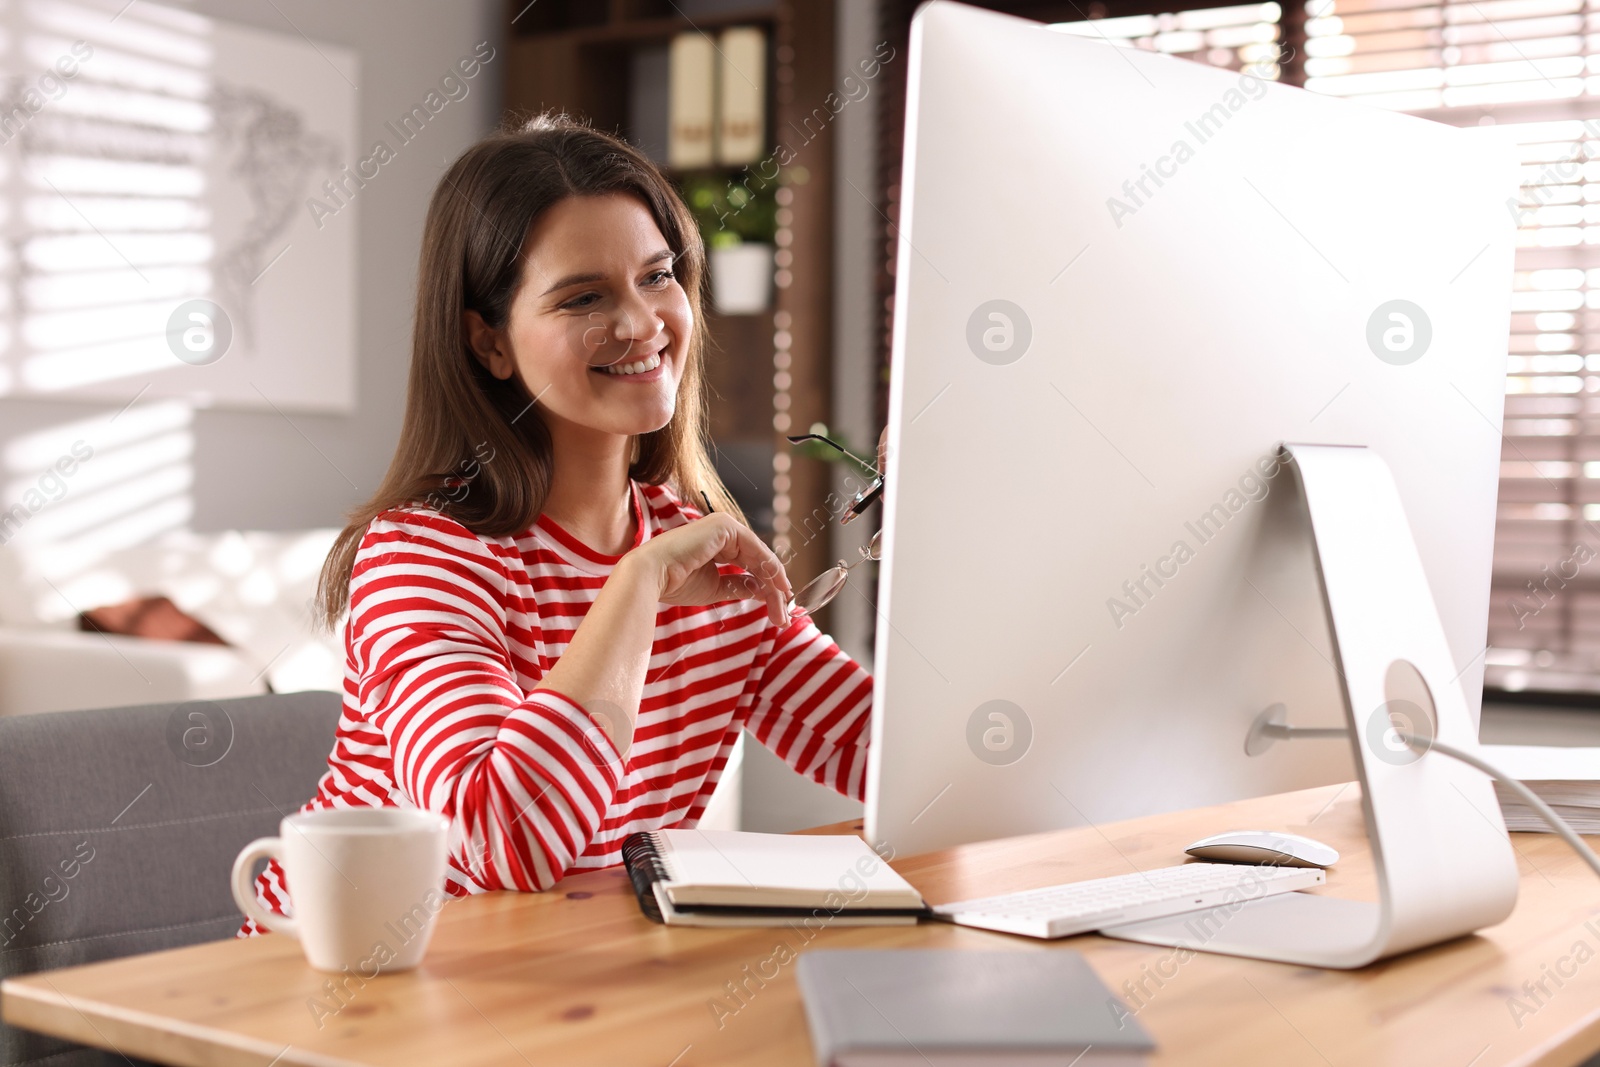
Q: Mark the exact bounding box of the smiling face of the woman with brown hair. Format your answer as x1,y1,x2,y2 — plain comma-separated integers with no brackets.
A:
467,194,694,435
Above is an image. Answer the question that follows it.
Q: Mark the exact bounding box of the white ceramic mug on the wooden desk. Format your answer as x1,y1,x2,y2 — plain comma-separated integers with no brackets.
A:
234,808,450,977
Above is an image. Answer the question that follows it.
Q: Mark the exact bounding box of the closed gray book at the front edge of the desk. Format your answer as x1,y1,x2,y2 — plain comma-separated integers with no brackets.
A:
795,949,1155,1067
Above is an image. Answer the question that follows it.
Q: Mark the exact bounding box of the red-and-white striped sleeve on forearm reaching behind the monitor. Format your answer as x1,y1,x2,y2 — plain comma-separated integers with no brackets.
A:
749,613,872,800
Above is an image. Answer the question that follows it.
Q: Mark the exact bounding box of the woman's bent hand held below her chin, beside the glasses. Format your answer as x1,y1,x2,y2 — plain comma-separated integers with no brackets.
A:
629,512,794,625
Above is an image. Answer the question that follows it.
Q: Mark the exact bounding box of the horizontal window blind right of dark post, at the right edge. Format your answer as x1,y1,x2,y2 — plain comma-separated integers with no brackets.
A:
1304,0,1600,691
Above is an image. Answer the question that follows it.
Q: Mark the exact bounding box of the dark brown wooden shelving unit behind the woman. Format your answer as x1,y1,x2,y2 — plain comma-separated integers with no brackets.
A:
504,0,838,607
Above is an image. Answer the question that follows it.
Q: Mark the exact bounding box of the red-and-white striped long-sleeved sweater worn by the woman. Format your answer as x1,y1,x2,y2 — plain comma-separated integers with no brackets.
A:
240,482,872,936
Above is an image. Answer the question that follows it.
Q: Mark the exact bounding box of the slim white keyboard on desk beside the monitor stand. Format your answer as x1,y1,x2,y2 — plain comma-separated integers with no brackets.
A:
933,864,1326,937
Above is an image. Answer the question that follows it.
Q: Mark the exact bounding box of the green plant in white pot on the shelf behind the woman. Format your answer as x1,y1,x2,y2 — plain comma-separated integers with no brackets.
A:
683,173,778,315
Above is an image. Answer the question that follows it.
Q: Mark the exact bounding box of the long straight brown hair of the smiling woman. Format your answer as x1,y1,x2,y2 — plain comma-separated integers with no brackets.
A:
317,114,746,627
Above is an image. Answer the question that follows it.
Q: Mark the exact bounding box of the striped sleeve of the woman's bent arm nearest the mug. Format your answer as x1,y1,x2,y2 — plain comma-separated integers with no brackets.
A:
349,512,622,891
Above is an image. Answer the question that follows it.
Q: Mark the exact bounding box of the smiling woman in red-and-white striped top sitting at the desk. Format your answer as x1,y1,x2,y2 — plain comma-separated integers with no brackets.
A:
242,117,872,934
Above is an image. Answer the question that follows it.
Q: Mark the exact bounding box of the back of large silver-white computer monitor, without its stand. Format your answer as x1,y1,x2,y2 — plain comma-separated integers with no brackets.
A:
866,0,1517,853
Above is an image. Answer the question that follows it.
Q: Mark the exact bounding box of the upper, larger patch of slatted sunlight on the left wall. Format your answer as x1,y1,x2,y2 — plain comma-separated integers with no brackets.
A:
15,0,216,390
